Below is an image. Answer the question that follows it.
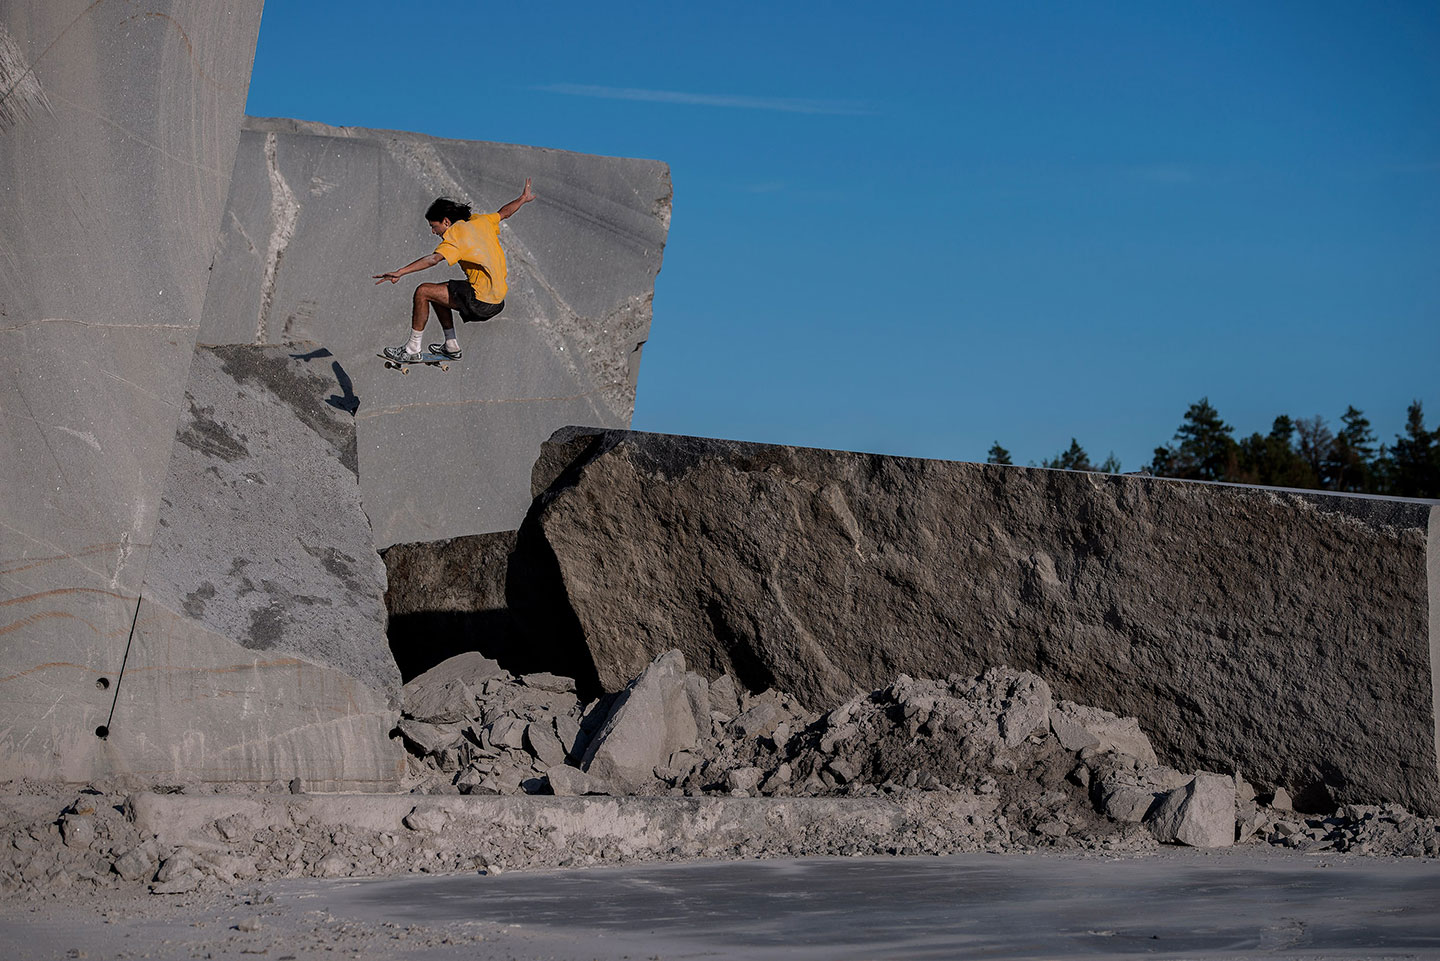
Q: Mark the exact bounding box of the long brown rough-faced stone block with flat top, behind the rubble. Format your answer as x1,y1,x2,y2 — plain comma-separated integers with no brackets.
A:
508,429,1440,813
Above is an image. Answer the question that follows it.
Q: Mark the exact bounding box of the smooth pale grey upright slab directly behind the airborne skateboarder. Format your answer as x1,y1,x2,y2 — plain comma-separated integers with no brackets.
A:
200,118,671,547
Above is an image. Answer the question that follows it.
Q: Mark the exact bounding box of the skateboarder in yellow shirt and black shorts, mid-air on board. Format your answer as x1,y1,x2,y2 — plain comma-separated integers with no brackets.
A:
374,180,536,363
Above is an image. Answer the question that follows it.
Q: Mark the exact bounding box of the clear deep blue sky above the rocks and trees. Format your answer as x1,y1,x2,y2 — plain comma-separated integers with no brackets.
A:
248,0,1440,470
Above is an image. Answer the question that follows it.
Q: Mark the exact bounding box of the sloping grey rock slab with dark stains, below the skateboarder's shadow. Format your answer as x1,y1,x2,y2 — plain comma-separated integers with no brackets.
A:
107,347,402,790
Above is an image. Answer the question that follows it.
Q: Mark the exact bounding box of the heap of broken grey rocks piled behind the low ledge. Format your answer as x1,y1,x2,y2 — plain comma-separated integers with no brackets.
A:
399,651,1440,856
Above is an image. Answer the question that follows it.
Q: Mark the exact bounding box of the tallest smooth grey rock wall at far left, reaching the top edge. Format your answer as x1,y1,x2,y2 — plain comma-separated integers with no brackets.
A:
0,0,261,778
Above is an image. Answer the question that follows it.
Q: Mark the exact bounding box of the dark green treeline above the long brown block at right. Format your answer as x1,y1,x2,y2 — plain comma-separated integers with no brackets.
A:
986,398,1440,497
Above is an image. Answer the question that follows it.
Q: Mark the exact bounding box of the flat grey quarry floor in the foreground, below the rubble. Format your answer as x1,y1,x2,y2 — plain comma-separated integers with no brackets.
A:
0,847,1440,961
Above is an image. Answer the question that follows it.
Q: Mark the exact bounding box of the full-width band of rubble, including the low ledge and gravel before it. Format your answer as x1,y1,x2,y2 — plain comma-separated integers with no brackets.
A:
0,651,1440,898
